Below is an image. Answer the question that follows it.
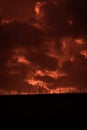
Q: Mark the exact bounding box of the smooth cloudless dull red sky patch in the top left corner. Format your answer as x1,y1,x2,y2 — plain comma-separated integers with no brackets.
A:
0,0,35,21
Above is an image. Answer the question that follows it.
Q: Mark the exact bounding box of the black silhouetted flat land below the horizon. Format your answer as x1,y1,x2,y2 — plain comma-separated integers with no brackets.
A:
0,94,87,130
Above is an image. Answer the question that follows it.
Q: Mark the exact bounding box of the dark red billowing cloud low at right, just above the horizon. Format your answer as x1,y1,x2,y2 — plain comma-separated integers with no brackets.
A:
51,54,87,88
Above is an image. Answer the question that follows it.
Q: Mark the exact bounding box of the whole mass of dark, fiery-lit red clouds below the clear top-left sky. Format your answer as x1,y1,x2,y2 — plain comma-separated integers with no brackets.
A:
0,0,87,92
